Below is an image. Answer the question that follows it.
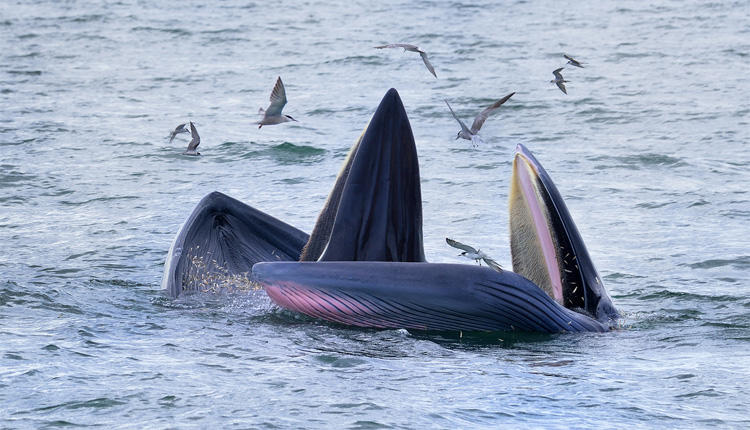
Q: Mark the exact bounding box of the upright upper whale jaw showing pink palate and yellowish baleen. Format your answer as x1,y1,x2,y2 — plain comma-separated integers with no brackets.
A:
509,145,617,319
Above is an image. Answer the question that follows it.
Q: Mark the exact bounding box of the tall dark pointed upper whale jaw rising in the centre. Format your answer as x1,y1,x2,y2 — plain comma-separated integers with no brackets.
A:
301,88,424,262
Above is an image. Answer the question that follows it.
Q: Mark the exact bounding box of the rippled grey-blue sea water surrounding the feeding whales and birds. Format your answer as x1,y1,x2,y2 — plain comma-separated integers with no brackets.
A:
0,0,750,428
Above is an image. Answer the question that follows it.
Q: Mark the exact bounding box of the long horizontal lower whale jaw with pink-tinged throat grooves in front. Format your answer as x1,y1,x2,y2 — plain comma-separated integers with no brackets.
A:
253,261,609,333
